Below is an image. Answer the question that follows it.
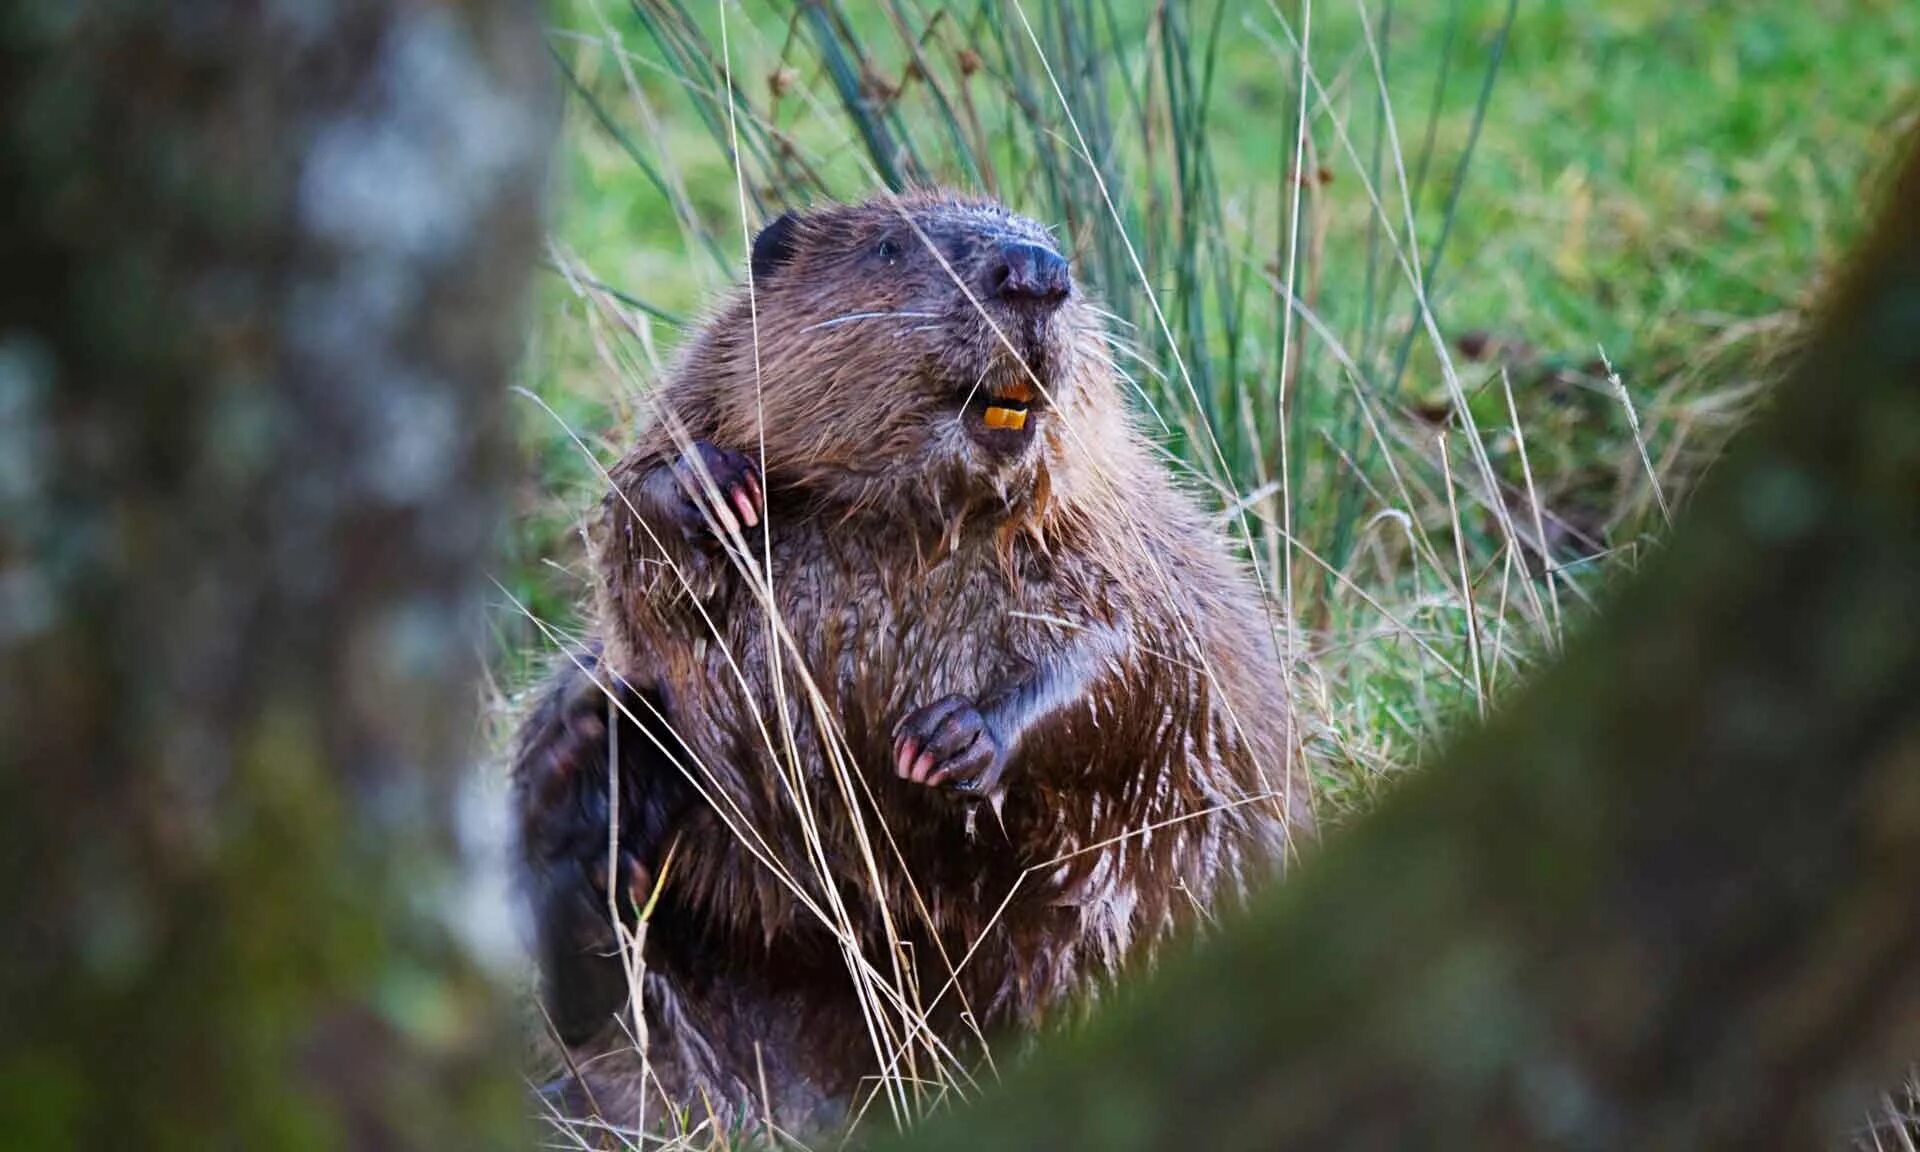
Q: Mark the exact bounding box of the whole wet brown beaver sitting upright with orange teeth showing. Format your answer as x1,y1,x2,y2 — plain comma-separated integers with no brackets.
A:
515,192,1313,1133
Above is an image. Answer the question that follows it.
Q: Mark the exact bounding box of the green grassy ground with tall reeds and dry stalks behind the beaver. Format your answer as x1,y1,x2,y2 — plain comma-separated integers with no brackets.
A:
495,0,1920,1144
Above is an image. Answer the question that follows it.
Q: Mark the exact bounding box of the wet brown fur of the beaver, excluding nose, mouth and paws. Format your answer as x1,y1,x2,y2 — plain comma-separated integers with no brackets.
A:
518,192,1311,1129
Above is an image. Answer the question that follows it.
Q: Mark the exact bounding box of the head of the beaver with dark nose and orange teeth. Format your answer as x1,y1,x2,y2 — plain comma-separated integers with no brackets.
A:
687,192,1117,515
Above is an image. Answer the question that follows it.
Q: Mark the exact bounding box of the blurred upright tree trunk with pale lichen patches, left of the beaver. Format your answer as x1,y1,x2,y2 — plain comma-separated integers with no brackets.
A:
0,0,553,1148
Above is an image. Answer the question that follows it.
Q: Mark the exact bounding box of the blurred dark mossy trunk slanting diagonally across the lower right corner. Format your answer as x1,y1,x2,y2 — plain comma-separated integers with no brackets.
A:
899,132,1920,1152
